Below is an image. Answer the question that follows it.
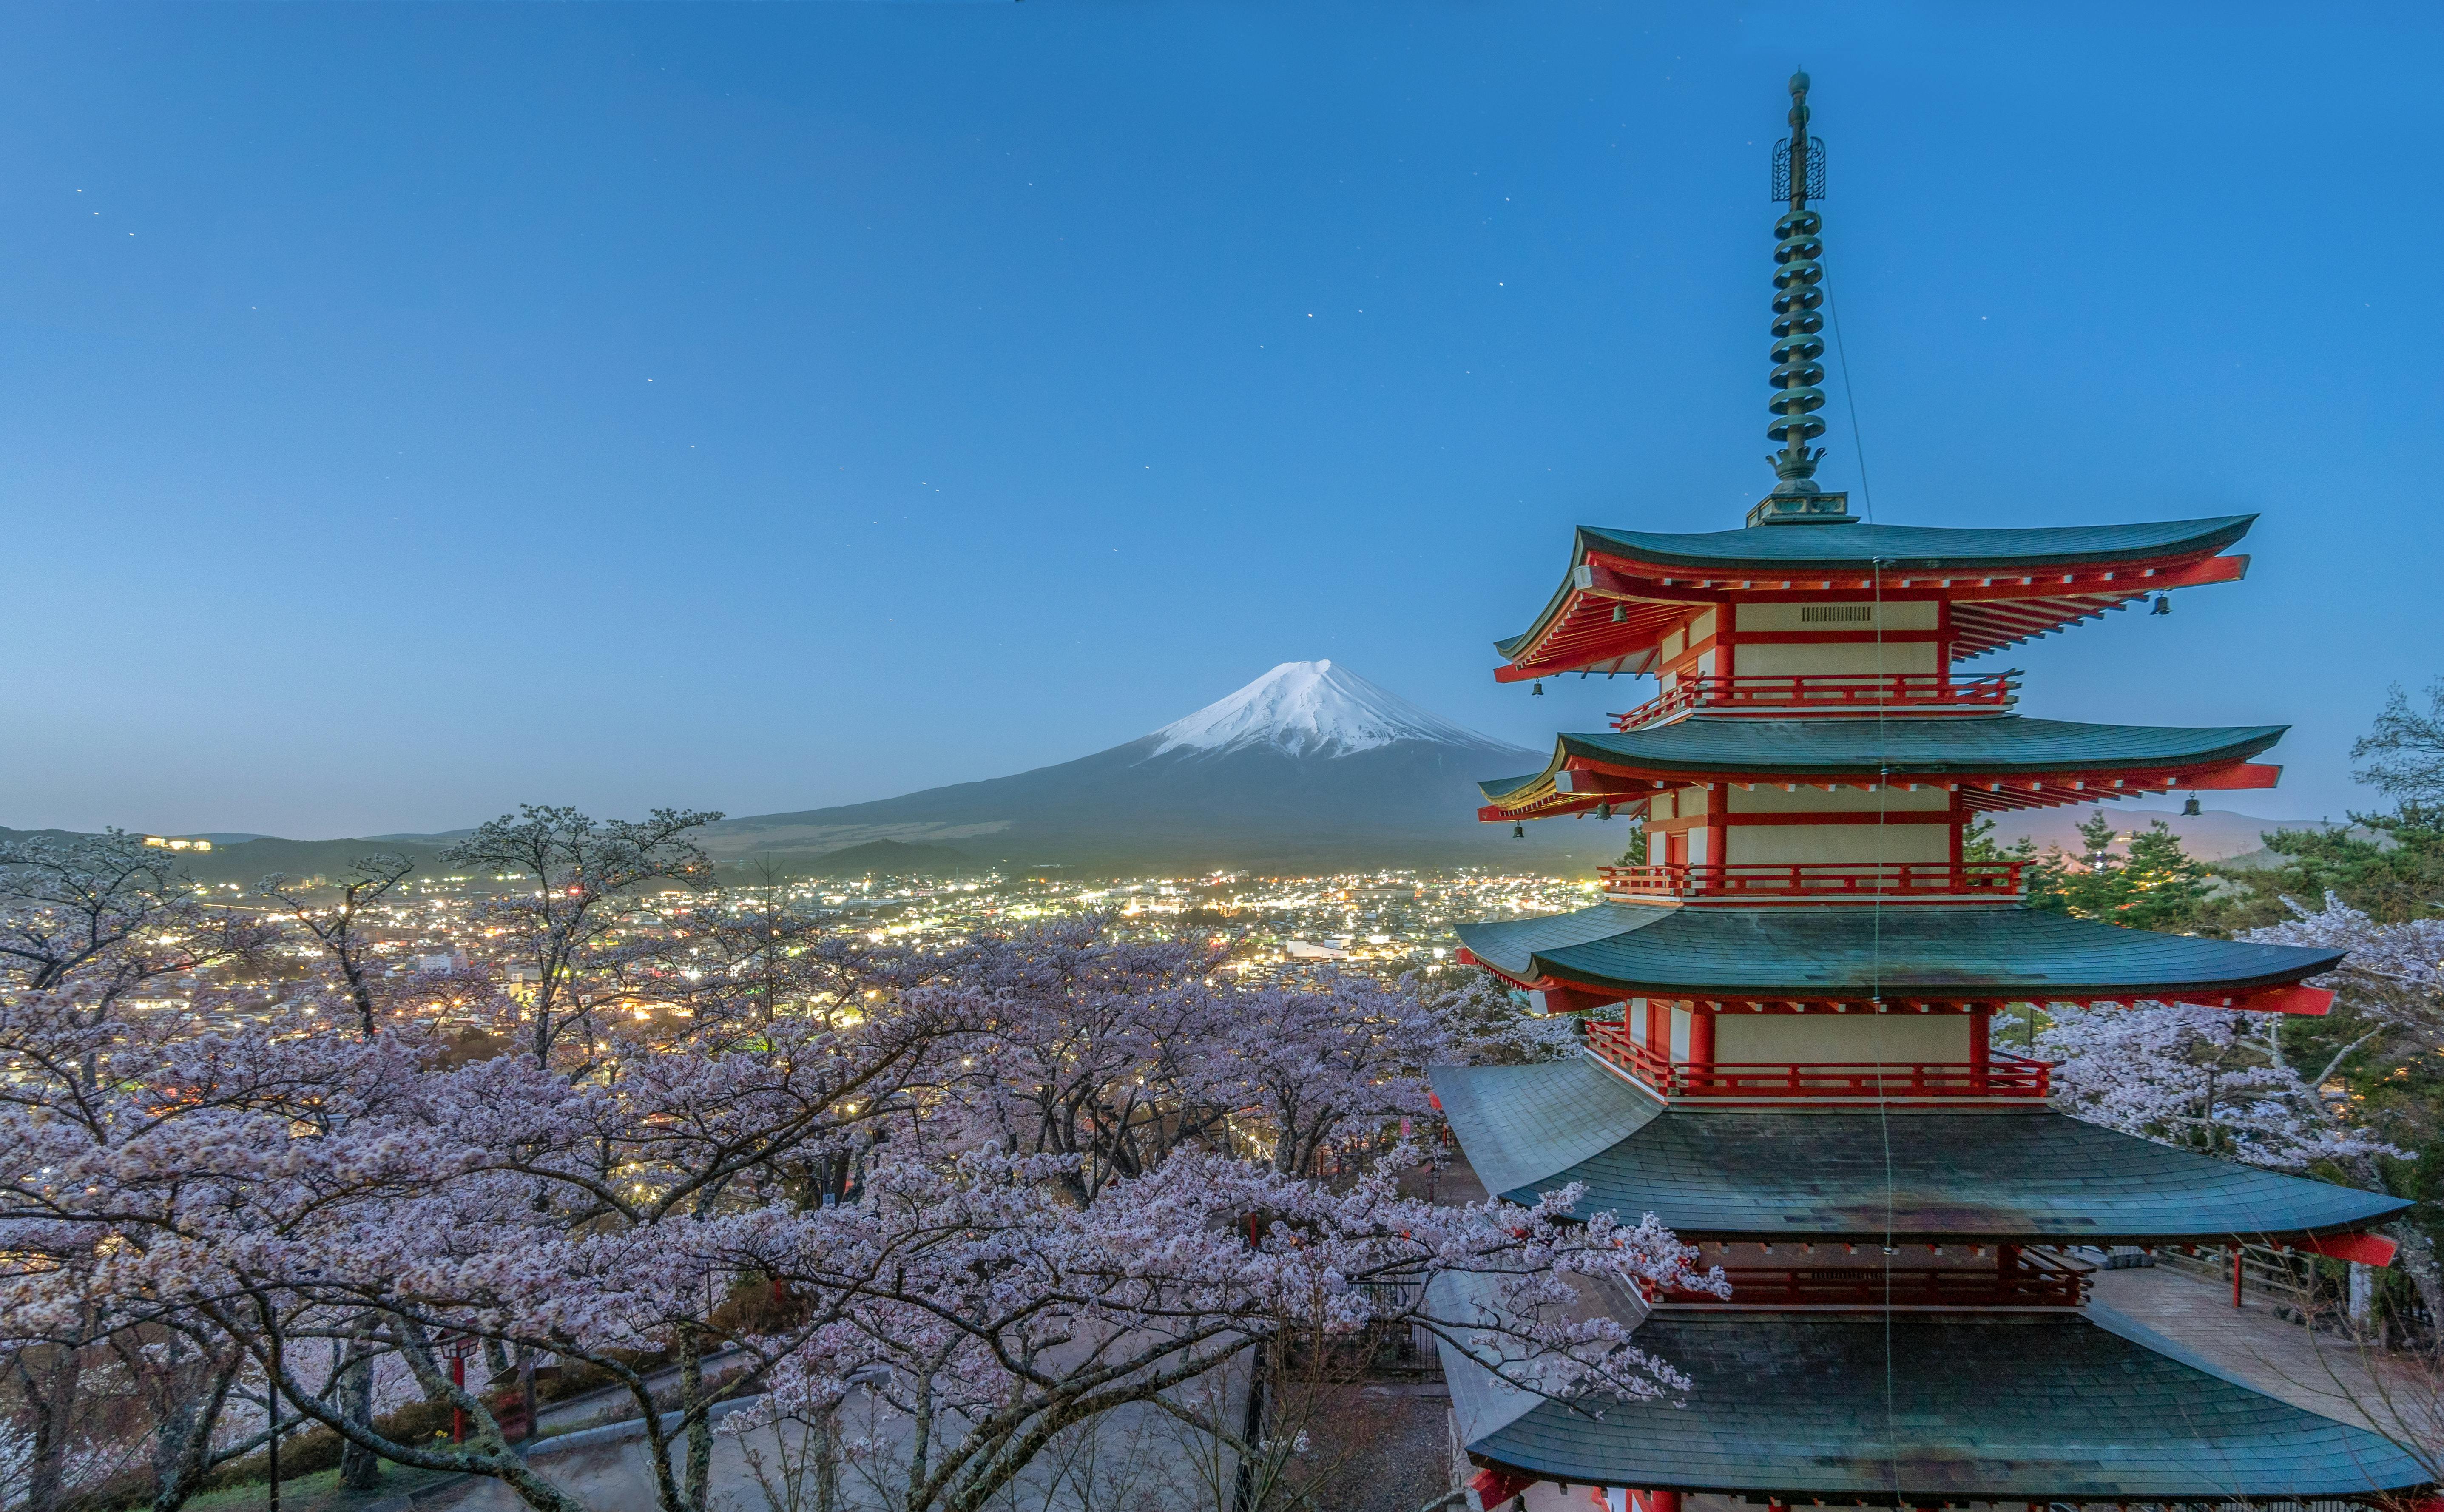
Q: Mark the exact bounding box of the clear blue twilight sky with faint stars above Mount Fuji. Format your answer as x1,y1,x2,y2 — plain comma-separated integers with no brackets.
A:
0,0,2444,836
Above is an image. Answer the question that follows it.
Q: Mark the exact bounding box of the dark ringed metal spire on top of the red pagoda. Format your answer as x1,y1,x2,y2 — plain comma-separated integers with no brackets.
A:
1748,68,1853,525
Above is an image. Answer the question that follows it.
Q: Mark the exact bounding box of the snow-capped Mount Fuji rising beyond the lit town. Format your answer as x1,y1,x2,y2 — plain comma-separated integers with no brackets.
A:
706,662,1625,872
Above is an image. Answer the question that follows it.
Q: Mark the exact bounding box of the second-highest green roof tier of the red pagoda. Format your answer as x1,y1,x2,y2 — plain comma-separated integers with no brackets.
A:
1479,713,2290,818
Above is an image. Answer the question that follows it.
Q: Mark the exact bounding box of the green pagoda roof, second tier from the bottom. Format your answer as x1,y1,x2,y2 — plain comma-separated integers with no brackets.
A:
1432,1055,2410,1241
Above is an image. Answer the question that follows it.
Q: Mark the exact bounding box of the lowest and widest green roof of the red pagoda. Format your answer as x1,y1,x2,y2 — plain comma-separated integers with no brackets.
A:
1437,1275,2430,1507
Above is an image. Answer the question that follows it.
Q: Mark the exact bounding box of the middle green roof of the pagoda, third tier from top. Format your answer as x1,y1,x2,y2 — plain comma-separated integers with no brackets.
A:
1459,899,2344,1001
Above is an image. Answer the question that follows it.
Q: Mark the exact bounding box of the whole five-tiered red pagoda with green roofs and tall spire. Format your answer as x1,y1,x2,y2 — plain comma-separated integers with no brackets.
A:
1435,73,2434,1512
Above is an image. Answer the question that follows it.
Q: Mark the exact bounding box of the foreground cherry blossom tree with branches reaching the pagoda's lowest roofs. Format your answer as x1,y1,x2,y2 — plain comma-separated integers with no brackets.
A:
733,1151,1725,1512
